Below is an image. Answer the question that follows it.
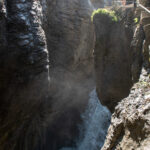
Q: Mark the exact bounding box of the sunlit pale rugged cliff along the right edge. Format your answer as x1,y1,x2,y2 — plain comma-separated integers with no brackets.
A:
102,0,150,150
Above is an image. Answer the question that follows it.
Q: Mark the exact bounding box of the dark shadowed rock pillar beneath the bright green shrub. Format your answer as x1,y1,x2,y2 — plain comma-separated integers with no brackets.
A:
93,8,144,112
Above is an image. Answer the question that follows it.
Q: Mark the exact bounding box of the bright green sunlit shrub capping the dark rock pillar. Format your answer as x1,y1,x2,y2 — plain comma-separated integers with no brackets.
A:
91,8,118,22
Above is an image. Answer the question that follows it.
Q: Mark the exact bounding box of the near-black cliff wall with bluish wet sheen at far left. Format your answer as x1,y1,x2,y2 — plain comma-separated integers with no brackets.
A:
0,0,49,150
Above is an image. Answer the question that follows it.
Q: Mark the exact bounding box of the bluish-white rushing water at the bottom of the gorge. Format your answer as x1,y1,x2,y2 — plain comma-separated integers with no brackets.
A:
61,90,111,150
